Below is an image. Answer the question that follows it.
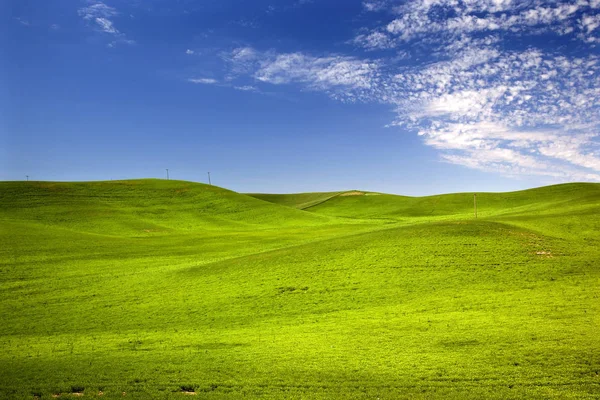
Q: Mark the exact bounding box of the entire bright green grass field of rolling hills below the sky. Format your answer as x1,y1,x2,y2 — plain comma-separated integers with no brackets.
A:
0,180,600,399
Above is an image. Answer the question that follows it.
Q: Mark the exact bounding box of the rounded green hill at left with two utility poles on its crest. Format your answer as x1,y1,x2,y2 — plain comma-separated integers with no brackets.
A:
0,179,330,235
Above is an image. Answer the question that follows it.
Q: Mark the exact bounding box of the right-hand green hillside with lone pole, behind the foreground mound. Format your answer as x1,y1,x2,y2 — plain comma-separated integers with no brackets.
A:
307,183,600,240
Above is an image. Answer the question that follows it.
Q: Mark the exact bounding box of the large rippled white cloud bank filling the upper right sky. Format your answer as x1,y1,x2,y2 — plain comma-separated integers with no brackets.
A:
216,0,600,181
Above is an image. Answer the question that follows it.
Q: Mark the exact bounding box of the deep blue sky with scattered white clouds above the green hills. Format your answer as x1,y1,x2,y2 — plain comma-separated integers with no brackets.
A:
0,0,600,195
